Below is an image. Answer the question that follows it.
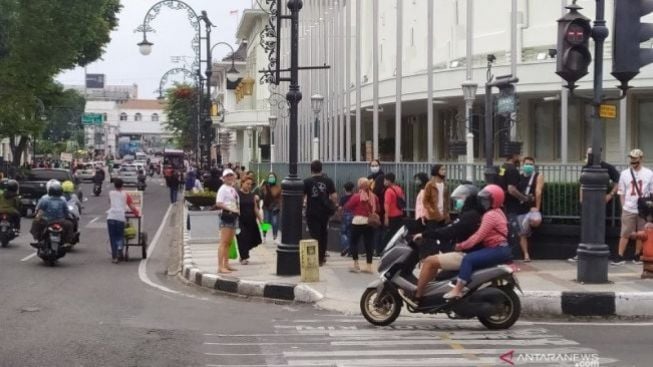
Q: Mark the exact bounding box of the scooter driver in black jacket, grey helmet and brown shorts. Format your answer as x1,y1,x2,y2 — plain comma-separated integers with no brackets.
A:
404,184,483,307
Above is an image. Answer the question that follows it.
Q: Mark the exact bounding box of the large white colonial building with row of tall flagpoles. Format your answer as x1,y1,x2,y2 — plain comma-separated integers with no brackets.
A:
223,0,653,167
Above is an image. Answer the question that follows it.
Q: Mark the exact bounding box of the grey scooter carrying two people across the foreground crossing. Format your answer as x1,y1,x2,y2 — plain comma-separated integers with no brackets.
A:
360,226,523,330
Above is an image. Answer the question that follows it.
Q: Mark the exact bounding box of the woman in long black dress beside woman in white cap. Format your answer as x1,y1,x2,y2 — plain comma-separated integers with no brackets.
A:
238,176,263,265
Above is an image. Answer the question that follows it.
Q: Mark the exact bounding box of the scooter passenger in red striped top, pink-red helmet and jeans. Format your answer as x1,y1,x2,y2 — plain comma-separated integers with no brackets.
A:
443,185,512,299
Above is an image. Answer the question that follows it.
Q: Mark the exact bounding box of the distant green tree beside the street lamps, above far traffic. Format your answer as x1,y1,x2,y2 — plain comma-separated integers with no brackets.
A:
165,84,197,151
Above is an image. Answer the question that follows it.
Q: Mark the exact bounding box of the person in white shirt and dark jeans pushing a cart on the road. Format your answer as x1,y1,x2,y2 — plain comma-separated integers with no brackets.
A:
107,178,140,264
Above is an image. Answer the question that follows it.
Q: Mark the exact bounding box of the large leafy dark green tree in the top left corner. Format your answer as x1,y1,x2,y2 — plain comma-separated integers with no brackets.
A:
0,0,121,164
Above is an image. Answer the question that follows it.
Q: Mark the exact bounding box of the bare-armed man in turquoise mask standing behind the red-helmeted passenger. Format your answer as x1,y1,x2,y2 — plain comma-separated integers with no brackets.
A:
517,157,544,262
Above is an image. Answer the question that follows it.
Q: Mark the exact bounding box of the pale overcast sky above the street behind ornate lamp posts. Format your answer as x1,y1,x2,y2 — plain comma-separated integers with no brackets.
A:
57,0,255,99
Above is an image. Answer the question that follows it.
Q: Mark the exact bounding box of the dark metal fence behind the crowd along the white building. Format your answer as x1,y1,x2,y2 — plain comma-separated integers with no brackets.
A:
250,162,625,226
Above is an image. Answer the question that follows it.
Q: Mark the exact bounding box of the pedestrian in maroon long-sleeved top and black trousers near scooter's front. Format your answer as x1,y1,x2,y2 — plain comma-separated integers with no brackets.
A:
345,177,380,273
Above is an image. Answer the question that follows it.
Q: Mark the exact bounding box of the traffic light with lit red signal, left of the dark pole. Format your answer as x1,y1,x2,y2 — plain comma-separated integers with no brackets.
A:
556,4,592,88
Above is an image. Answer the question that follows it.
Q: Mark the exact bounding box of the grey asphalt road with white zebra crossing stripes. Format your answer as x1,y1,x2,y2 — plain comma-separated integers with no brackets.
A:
0,179,653,367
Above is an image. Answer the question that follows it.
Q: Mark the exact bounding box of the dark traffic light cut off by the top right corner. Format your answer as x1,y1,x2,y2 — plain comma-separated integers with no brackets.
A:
612,0,653,85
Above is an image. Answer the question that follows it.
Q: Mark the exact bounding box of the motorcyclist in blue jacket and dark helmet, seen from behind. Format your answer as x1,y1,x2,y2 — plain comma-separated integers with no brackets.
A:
30,180,72,243
